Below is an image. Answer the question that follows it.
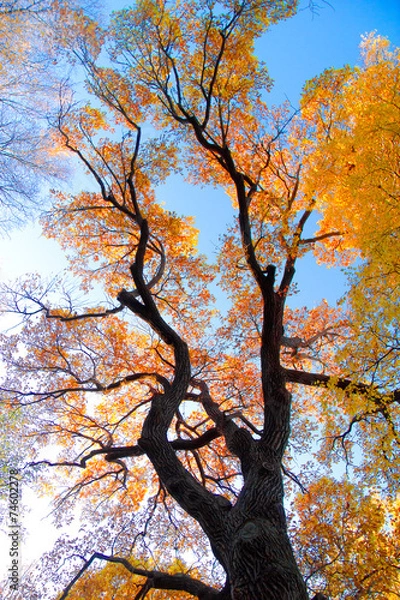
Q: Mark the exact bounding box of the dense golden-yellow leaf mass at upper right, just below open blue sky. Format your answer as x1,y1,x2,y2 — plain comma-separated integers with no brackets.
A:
302,35,400,263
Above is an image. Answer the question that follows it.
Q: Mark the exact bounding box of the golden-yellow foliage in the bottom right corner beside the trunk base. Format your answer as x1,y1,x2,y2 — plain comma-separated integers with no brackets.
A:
293,477,400,600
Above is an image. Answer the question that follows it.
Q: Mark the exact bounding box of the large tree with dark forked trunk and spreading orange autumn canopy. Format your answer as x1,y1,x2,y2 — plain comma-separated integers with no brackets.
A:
1,0,399,600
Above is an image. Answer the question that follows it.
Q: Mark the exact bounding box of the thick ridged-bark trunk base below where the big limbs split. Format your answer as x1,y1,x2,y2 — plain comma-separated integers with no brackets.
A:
216,461,308,600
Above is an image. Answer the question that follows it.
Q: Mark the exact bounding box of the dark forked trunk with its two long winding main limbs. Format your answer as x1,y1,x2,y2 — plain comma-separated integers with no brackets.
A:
118,110,308,600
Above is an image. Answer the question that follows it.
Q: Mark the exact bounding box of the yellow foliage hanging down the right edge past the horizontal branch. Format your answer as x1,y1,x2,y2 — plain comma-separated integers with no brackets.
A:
292,34,400,496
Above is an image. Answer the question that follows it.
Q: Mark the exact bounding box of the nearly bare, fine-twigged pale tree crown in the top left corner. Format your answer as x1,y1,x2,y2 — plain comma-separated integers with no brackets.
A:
0,0,95,231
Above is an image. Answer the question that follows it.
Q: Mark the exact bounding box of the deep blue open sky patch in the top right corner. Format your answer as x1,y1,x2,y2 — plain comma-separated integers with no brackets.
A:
259,0,400,104
